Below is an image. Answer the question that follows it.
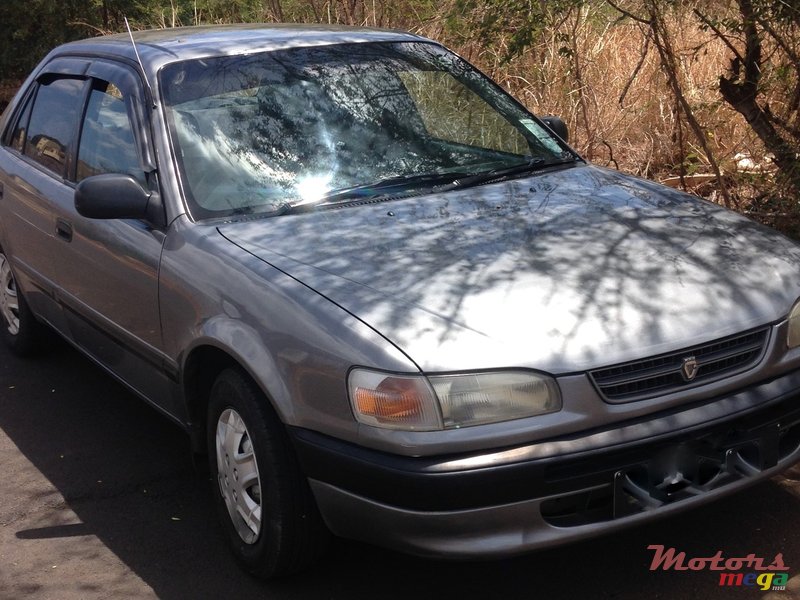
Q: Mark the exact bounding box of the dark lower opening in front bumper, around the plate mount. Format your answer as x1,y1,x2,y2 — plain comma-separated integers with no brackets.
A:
539,395,800,527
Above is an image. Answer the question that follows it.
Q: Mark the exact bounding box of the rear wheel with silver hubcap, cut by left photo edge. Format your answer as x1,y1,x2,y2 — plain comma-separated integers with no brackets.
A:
0,248,44,356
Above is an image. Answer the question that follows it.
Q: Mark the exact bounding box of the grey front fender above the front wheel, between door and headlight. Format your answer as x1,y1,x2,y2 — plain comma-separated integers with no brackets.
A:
159,217,418,441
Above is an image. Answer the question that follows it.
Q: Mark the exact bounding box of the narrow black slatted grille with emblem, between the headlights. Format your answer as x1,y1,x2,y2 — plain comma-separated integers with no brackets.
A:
589,327,769,402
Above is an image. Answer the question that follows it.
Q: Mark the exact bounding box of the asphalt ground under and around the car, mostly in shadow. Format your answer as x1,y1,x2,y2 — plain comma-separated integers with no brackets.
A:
0,336,800,600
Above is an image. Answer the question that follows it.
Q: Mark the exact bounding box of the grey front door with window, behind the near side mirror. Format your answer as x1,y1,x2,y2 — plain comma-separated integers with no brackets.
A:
54,61,174,412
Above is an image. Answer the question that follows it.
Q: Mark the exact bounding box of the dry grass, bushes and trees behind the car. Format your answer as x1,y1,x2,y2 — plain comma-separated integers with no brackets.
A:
0,0,800,238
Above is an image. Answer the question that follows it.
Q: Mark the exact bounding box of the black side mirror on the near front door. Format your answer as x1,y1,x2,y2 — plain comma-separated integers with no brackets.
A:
75,173,163,225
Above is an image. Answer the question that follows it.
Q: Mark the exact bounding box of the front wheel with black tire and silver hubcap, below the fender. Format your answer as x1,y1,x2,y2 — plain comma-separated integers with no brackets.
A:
207,369,329,579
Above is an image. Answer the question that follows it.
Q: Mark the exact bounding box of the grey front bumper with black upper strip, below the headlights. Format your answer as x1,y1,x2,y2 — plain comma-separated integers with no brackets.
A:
290,371,800,558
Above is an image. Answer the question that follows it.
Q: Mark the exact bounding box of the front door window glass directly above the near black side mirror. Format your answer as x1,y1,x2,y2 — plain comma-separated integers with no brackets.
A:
77,81,146,186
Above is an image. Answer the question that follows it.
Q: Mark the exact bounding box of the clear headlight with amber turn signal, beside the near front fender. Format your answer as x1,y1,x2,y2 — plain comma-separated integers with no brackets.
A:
348,369,561,431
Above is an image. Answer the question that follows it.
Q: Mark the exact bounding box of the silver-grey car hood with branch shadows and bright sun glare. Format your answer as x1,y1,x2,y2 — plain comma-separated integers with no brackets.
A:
219,165,800,374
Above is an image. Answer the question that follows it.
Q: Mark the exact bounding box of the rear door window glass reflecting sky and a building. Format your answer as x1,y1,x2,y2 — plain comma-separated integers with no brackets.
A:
25,79,84,176
